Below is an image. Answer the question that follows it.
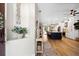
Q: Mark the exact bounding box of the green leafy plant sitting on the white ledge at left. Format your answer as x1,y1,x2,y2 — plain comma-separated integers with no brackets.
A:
12,26,27,38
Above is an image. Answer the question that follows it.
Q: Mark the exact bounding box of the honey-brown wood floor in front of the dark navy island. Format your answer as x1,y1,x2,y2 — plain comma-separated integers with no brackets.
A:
48,37,79,56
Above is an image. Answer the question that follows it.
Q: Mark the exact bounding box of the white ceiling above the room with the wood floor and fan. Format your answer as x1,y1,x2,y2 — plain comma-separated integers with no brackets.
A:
38,3,79,24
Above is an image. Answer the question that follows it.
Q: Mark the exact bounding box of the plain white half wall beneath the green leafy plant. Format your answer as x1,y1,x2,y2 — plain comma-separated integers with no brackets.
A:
6,38,35,56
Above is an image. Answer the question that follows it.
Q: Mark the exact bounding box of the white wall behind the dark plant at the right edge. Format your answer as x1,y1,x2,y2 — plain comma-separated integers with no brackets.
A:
66,16,78,40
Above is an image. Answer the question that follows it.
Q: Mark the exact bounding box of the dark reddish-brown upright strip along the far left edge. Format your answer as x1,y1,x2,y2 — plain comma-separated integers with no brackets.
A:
0,3,5,56
